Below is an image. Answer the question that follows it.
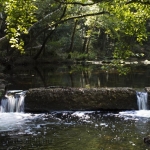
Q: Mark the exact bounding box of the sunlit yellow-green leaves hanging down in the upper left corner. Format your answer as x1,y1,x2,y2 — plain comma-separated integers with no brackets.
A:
0,0,37,53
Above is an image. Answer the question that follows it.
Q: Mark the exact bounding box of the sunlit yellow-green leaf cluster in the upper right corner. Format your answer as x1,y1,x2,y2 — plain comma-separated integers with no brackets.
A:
107,0,150,42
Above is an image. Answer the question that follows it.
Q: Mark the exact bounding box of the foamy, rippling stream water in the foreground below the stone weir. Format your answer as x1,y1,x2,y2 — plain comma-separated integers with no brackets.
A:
0,111,150,150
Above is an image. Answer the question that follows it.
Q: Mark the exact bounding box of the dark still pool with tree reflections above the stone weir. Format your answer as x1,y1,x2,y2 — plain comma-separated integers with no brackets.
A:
7,64,150,90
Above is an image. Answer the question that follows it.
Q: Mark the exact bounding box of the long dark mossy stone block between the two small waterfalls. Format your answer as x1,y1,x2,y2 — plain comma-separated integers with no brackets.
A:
25,88,138,112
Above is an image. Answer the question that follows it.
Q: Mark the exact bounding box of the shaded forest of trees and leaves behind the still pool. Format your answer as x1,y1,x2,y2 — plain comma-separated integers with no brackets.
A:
0,0,150,66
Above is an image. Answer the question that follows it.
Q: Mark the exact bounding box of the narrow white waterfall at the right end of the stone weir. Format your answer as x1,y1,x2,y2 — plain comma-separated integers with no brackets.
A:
136,92,148,110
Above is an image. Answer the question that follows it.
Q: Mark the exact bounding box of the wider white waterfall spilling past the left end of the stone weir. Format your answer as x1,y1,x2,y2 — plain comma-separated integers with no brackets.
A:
0,90,26,112
